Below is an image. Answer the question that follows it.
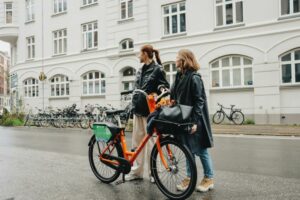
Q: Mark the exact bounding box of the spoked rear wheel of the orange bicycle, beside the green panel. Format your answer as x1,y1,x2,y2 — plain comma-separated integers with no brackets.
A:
89,136,123,183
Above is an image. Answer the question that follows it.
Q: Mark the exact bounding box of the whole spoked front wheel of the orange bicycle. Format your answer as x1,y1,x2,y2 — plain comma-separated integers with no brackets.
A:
150,138,197,199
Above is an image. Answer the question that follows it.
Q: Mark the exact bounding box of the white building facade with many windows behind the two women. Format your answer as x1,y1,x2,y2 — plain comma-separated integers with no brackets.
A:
0,0,300,124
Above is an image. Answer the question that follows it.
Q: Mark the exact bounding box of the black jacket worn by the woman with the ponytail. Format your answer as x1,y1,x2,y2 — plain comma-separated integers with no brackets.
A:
132,61,170,117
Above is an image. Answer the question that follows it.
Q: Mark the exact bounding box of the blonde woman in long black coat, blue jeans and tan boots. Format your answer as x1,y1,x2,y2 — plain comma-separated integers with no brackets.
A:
171,49,214,192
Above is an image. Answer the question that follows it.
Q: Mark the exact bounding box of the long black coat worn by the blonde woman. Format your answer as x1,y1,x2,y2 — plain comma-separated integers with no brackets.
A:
171,71,213,148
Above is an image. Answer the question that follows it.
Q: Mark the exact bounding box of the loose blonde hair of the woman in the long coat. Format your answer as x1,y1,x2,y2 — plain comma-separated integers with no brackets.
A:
178,49,200,71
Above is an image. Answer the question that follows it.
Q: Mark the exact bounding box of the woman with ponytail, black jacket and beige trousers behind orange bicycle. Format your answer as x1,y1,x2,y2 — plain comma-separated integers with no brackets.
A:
125,45,169,182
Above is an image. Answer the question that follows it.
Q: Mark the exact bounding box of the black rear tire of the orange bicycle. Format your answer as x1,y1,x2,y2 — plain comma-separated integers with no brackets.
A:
89,136,123,184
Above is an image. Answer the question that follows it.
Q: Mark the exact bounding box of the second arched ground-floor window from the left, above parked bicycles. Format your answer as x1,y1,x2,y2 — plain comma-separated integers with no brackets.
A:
50,75,70,97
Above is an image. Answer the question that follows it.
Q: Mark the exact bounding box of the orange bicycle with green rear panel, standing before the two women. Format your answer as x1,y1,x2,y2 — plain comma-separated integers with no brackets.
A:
89,90,197,199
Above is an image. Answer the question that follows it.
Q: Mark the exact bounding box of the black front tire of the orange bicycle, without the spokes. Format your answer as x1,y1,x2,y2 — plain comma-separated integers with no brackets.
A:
150,137,197,200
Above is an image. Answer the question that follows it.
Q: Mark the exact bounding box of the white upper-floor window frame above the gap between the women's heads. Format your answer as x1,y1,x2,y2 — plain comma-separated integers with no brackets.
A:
161,0,187,37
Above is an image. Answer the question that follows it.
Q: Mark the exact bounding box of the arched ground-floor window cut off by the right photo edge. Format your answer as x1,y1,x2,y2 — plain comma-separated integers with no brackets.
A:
280,49,300,84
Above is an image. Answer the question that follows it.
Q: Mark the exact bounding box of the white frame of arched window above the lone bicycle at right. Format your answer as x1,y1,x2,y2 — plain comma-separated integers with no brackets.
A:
209,54,254,90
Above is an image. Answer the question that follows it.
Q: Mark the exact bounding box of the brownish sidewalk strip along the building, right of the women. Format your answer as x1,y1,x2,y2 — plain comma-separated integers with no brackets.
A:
212,124,300,137
